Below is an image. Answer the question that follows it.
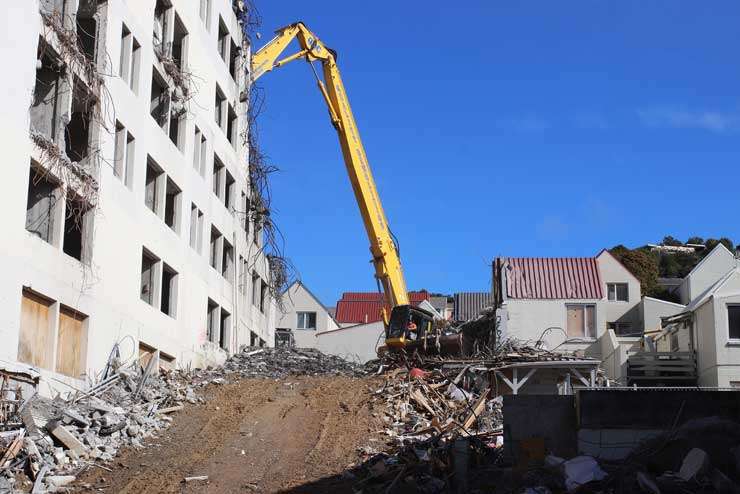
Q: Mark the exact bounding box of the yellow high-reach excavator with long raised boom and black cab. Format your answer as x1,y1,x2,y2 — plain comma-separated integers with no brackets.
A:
250,22,439,350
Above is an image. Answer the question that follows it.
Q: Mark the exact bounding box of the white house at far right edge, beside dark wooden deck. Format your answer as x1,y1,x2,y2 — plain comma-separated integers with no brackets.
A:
630,244,740,388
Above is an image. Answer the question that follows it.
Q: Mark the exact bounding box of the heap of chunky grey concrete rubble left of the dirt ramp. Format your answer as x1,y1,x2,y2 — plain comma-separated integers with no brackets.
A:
0,356,200,493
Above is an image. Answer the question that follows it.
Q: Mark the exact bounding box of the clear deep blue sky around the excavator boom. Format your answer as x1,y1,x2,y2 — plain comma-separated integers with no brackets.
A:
251,0,740,305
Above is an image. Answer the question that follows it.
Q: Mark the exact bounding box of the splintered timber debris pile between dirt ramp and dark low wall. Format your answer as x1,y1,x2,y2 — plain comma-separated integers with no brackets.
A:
352,364,503,493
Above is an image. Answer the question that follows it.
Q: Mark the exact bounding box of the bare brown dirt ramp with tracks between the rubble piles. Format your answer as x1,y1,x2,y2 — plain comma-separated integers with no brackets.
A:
77,377,379,493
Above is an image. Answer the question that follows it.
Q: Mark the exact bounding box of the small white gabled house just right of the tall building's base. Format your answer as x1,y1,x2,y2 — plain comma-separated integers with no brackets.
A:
276,281,340,348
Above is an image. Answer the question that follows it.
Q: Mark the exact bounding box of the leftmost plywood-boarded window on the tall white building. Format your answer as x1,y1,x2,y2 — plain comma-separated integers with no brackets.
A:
18,290,54,370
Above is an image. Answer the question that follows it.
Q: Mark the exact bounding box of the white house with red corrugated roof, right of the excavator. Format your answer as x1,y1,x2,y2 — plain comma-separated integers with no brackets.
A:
493,249,642,353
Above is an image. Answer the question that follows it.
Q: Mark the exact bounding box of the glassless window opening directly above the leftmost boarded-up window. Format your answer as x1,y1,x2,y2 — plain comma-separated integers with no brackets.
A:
26,166,61,245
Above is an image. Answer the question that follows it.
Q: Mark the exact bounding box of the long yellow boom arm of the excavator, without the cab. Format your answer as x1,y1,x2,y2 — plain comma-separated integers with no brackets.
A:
251,22,409,316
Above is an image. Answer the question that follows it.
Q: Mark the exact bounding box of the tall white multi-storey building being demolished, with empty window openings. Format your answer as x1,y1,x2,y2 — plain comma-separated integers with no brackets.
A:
0,0,275,390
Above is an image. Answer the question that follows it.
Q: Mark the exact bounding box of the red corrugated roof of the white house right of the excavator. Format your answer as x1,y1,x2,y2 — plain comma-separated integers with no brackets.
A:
503,257,604,299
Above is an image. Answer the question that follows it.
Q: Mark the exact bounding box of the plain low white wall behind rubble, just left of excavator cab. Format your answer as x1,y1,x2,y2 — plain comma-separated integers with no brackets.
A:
316,321,385,363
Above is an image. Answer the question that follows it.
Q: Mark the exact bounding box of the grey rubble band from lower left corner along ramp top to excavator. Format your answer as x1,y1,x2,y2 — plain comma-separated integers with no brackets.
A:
0,348,366,494
